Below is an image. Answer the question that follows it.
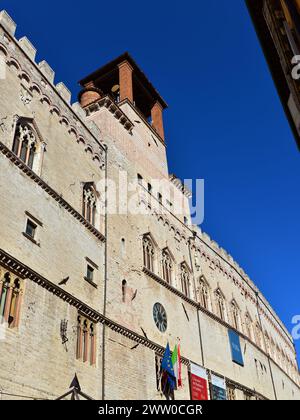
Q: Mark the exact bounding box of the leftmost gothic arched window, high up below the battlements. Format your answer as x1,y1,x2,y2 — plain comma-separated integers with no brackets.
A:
13,122,37,169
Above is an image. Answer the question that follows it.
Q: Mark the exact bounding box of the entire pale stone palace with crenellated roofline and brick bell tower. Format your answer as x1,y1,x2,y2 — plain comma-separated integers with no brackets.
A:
0,11,300,400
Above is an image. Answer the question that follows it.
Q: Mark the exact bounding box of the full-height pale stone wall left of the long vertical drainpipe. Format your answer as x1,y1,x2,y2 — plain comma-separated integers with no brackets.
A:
0,10,104,399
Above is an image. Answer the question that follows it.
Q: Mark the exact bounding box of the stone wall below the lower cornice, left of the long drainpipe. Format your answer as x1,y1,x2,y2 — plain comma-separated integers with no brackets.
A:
0,280,102,400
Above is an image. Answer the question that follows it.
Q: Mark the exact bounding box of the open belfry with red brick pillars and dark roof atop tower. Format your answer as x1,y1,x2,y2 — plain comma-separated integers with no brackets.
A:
79,52,167,141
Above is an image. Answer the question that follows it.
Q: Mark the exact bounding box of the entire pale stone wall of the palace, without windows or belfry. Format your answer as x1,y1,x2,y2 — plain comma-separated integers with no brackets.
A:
0,7,300,399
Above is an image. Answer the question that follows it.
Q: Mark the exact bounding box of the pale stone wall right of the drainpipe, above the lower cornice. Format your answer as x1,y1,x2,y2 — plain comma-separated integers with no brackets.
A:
89,97,300,399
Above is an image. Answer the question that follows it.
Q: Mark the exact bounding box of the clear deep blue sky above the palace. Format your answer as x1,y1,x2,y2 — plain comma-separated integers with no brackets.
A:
0,0,300,360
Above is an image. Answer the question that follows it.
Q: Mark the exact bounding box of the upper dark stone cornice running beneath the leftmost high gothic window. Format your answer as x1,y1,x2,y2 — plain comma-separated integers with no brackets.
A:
0,142,105,242
